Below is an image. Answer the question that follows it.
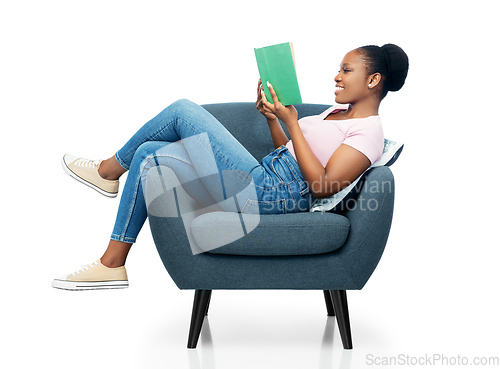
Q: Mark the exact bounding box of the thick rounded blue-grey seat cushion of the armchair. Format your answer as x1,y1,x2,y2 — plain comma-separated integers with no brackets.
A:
191,212,350,256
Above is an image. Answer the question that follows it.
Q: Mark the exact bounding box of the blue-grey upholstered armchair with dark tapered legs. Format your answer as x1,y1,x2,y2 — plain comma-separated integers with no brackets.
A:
148,103,394,349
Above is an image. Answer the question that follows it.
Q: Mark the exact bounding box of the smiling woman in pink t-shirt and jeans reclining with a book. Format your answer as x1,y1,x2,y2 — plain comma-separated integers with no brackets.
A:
52,44,408,290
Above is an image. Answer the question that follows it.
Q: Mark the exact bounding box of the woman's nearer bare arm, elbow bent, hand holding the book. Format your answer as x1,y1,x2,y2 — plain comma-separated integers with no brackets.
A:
261,82,371,198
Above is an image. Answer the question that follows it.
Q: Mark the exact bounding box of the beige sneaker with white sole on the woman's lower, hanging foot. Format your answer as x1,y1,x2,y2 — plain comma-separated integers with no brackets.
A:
52,260,128,291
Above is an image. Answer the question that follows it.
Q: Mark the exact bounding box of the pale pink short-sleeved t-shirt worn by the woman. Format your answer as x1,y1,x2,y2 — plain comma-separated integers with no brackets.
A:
286,104,384,167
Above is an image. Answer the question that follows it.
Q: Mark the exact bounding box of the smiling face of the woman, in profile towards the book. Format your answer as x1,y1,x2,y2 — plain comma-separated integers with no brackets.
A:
335,50,370,104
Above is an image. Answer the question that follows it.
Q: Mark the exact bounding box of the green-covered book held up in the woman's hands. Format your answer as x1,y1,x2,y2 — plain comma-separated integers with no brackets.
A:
254,42,302,105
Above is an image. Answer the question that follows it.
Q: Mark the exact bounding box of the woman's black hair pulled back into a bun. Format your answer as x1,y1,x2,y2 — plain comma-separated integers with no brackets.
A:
358,44,408,99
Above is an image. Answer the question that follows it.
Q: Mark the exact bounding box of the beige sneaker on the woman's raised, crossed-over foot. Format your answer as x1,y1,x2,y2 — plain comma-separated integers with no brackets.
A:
62,154,120,197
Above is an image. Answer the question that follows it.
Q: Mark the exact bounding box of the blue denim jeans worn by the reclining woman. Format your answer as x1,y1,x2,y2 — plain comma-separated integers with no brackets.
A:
111,100,314,243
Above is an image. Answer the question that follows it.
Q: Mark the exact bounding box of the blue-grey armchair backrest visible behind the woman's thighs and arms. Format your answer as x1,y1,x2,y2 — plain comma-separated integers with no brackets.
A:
202,102,329,160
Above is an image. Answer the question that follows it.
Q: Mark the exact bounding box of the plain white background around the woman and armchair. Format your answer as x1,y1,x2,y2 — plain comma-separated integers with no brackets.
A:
0,0,500,368
